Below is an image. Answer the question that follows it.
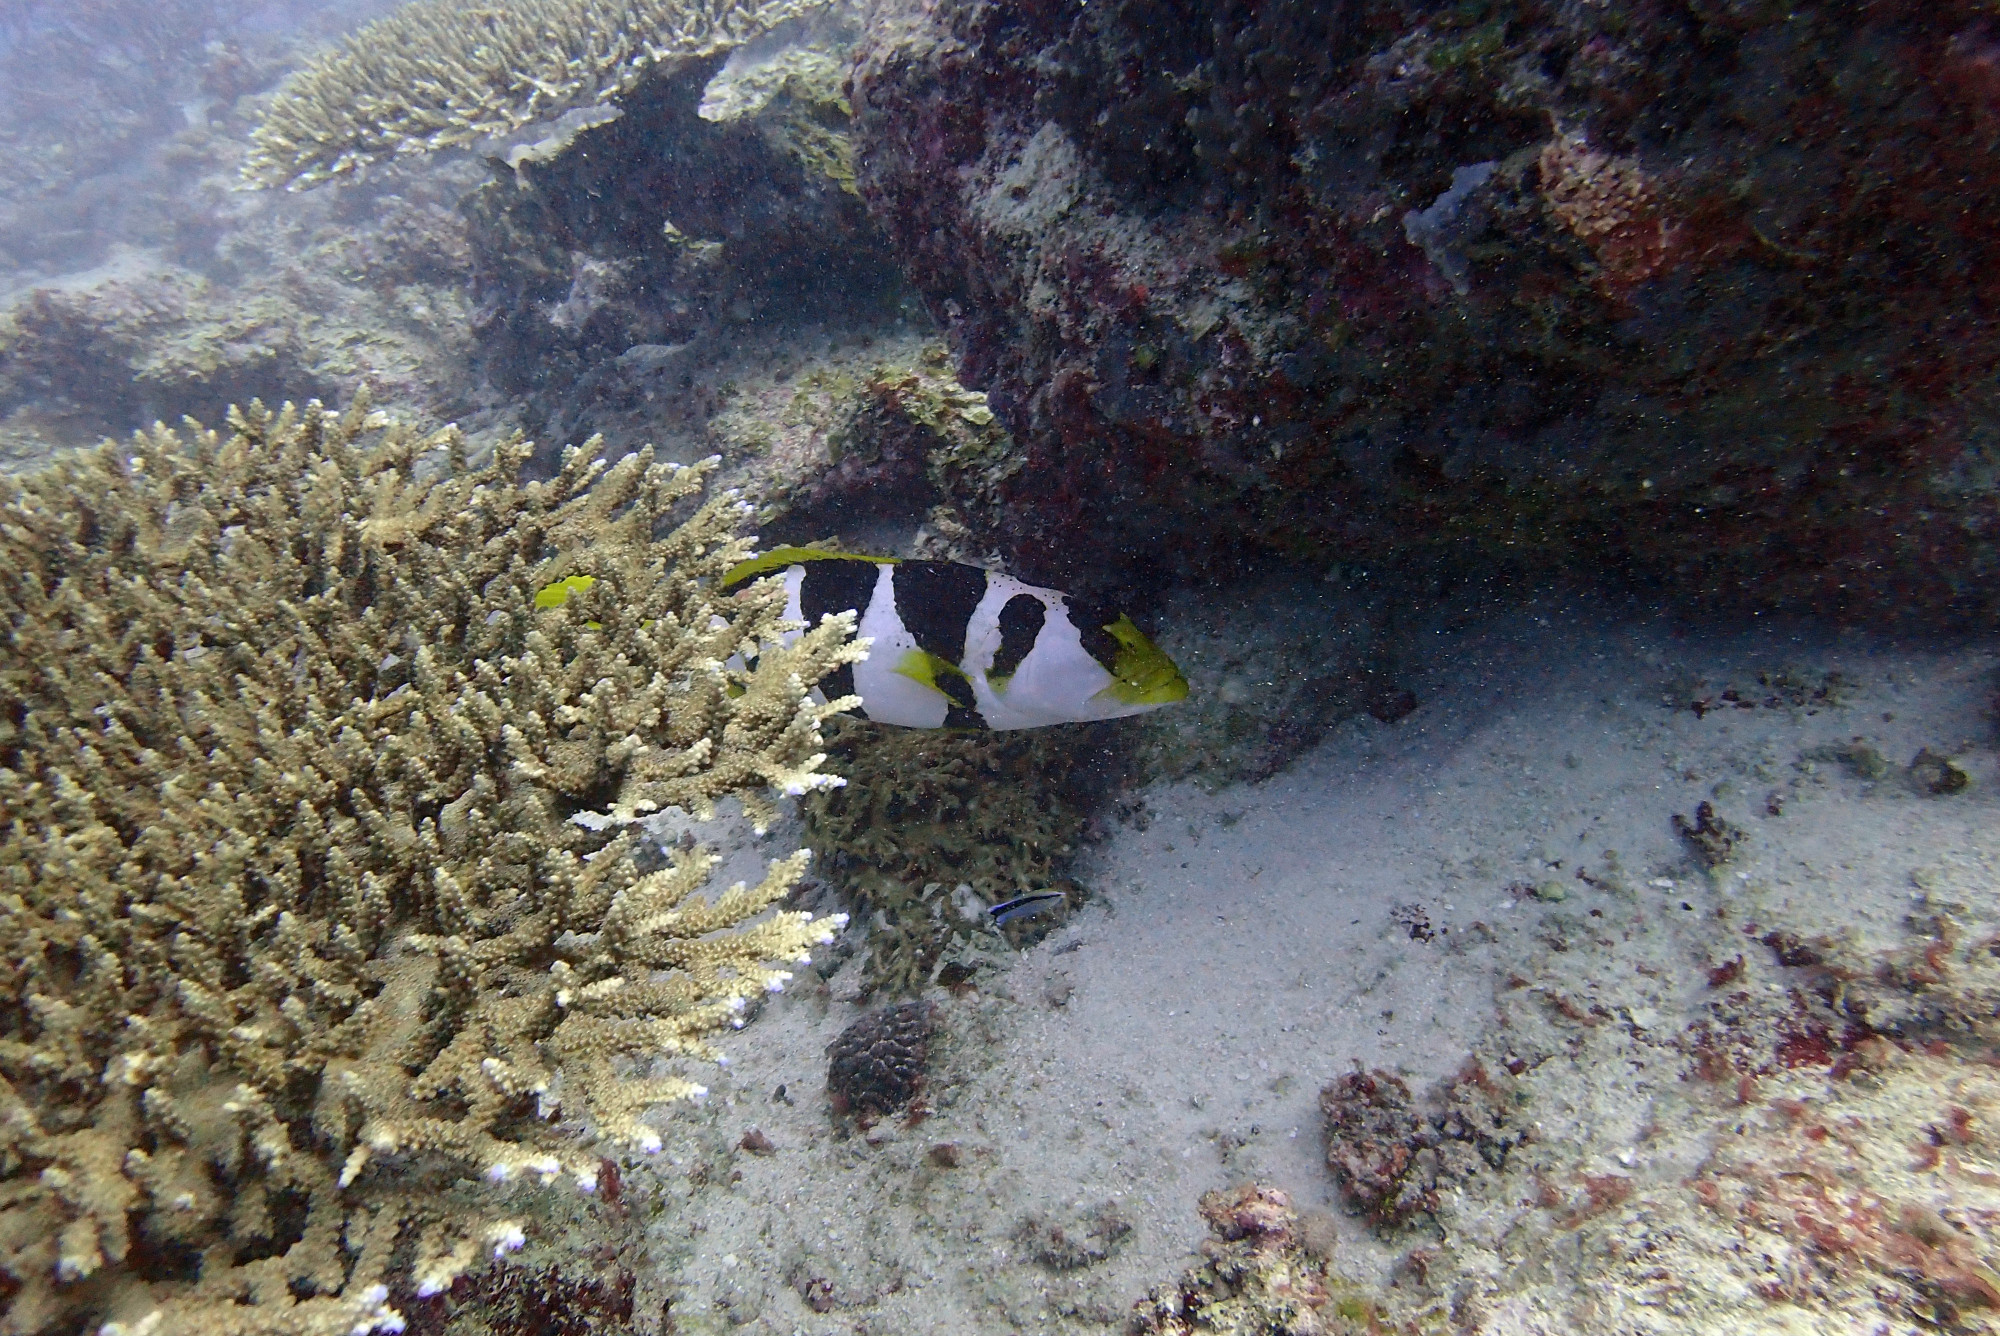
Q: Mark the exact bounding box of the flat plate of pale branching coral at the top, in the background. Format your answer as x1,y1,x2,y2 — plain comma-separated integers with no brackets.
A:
244,0,824,188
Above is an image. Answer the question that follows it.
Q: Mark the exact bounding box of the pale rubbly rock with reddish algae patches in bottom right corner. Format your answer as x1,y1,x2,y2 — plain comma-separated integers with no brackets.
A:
1480,894,2000,1334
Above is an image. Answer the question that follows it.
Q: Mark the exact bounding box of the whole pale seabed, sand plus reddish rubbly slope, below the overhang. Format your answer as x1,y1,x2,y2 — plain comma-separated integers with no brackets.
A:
628,596,2000,1336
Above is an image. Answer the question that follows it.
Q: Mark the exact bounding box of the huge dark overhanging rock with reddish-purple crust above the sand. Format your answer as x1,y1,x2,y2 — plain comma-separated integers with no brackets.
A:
852,0,2000,622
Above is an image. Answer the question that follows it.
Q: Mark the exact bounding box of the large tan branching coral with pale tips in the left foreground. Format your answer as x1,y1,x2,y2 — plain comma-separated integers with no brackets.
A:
0,404,862,1336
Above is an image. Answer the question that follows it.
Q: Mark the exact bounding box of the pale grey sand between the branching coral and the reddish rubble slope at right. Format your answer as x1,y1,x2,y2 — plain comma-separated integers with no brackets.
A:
628,598,2000,1336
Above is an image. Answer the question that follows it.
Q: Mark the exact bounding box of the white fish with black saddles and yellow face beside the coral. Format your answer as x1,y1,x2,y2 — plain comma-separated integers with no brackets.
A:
724,548,1188,728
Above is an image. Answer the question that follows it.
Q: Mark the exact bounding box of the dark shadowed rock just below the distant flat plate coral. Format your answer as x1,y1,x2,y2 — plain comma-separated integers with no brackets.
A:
462,17,900,460
